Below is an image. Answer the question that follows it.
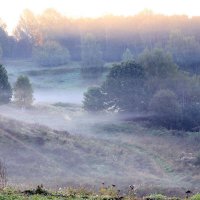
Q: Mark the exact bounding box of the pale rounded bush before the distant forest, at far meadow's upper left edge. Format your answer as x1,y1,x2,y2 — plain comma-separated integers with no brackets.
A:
33,41,70,66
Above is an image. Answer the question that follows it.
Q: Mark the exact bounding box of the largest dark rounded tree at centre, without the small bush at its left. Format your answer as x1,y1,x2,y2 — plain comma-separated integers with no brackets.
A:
102,61,145,112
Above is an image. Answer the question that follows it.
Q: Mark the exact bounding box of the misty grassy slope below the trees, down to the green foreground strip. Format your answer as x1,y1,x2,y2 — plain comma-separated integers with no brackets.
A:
0,106,200,195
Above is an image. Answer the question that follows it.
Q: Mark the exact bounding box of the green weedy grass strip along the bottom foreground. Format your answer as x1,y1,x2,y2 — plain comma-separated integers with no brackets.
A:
0,188,200,200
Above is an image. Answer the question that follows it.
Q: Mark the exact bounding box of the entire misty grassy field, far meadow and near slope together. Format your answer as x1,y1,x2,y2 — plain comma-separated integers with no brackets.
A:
0,61,200,199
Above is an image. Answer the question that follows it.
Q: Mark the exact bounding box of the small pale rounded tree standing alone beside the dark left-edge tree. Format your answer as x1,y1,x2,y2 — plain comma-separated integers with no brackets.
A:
14,76,33,107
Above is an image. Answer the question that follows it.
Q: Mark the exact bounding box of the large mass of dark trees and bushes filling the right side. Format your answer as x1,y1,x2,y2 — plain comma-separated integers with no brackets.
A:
84,46,200,131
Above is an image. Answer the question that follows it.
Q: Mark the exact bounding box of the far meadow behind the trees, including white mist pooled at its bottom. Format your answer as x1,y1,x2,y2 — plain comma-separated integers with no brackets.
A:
3,60,110,103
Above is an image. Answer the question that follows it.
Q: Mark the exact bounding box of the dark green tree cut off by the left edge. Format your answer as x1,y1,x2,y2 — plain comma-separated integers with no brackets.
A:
0,65,12,103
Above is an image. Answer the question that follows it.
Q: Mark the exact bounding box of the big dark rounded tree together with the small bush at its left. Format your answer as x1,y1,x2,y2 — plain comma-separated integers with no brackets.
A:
84,61,145,112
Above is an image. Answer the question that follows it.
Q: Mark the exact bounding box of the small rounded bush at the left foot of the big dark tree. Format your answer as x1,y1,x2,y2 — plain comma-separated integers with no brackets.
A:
83,87,104,111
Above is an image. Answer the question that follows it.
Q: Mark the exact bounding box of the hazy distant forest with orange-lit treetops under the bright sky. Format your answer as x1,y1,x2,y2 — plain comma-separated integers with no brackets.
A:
0,9,200,71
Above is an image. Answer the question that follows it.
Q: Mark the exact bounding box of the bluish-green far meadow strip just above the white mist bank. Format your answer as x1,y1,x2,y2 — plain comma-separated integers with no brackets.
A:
4,60,108,92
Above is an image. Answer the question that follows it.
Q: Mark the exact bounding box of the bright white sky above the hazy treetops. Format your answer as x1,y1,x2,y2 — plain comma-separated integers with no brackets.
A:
0,0,200,33
